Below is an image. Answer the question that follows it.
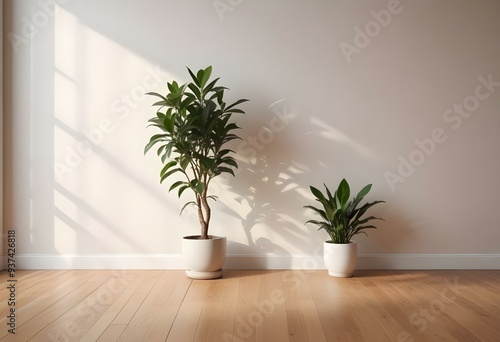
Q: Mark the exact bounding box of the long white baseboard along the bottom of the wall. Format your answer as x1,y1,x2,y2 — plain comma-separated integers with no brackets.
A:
8,254,500,270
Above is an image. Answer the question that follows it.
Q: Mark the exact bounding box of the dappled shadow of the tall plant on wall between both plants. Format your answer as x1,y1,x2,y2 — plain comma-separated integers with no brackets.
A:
212,96,320,260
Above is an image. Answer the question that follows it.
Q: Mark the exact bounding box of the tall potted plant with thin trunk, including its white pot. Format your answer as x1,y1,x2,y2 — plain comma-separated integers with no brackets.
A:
144,66,248,279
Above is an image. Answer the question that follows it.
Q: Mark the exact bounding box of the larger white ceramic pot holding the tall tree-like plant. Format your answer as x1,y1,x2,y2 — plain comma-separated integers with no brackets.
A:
182,235,226,279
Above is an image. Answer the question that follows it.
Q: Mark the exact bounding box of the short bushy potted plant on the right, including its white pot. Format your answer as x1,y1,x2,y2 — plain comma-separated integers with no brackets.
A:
305,179,384,277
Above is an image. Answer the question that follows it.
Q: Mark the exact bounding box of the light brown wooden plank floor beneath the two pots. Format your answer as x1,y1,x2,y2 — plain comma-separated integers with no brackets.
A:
0,270,500,342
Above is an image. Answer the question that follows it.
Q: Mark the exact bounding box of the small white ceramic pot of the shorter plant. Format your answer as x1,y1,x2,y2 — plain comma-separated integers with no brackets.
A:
323,241,358,278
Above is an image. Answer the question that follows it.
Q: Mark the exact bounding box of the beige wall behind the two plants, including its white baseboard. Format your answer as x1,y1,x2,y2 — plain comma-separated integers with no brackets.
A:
4,0,500,268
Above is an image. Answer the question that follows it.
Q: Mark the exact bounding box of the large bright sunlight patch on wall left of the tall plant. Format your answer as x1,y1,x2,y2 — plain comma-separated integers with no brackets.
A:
54,8,182,253
